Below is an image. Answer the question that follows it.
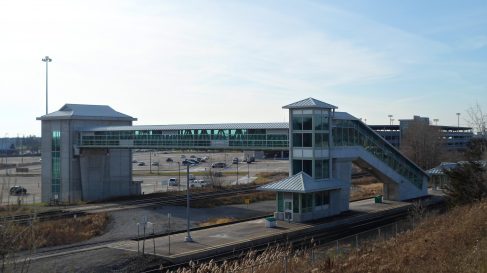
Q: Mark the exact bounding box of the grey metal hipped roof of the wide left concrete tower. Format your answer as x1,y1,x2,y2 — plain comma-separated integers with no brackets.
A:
37,104,137,121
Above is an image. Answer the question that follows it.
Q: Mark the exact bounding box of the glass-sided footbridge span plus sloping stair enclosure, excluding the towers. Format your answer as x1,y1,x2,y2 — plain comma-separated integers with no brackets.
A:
79,112,428,194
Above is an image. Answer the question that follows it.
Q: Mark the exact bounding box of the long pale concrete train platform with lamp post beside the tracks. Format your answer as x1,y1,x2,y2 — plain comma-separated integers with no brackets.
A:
109,196,424,263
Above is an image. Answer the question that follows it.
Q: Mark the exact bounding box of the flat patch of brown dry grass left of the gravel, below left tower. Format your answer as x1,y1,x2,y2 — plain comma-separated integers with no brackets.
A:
2,213,108,250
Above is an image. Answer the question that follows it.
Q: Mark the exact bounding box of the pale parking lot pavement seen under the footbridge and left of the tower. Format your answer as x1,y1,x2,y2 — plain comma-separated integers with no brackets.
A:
0,151,289,204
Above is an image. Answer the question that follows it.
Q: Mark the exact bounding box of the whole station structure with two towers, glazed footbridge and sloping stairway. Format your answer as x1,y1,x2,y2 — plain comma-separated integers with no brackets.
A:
38,98,428,222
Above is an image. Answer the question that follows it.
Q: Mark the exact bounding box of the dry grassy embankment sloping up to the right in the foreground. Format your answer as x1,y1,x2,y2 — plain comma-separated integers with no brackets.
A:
167,201,487,273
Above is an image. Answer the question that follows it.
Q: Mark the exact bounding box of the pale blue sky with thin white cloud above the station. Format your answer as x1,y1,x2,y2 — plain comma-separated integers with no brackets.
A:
0,0,487,137
